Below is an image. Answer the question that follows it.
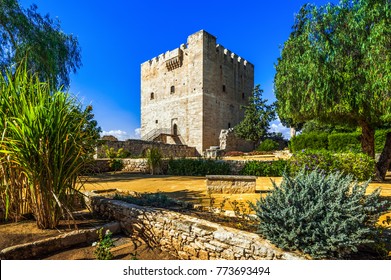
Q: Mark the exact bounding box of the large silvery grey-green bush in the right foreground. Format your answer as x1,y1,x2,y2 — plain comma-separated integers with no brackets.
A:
252,170,390,259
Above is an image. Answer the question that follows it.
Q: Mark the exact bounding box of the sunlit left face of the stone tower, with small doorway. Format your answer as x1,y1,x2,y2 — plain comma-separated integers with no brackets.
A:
141,33,203,155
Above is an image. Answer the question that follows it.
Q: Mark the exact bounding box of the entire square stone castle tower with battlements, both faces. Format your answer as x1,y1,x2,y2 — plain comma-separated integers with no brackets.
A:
141,30,254,154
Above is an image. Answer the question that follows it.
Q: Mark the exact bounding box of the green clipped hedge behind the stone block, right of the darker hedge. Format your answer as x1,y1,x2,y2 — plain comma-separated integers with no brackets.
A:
239,159,288,177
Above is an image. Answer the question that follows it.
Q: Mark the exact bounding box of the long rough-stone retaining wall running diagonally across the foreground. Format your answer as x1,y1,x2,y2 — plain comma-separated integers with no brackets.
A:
87,193,305,260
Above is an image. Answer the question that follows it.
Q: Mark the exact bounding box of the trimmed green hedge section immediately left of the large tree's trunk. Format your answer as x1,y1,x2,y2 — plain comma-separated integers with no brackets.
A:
328,132,361,152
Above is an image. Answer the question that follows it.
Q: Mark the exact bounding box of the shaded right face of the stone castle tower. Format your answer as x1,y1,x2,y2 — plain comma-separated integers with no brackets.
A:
203,33,254,149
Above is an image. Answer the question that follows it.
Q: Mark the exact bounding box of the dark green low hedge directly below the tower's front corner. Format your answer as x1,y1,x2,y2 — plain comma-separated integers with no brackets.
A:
168,159,231,176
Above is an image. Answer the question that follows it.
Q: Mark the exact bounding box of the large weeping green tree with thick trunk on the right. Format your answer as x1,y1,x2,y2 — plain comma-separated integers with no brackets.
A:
274,0,391,178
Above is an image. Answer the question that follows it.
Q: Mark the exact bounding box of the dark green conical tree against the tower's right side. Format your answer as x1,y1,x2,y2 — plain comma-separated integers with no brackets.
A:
234,85,276,147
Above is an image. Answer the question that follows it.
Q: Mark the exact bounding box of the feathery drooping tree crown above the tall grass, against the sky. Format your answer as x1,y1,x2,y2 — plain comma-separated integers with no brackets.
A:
0,0,82,88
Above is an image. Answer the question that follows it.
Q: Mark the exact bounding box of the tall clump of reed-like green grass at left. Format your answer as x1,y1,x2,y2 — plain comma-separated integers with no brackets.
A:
0,64,99,228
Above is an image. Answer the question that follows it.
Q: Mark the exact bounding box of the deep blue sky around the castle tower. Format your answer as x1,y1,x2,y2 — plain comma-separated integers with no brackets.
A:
19,0,338,139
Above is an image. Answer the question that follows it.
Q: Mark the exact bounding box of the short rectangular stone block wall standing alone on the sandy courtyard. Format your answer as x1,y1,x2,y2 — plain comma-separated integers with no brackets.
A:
206,175,257,194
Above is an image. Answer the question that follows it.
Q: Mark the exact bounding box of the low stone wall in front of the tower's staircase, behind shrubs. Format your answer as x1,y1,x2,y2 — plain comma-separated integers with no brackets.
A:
96,139,198,158
